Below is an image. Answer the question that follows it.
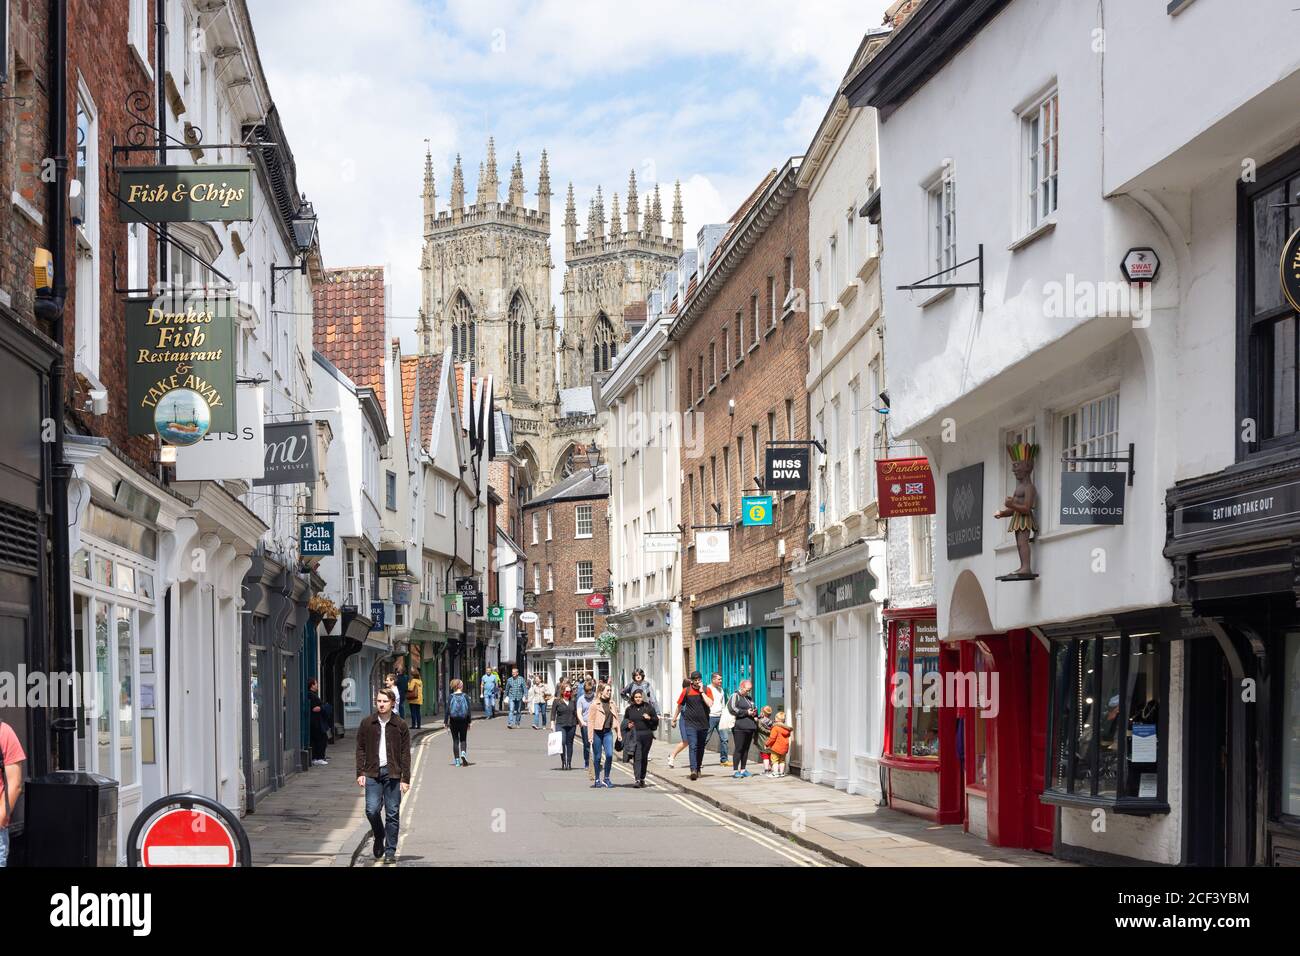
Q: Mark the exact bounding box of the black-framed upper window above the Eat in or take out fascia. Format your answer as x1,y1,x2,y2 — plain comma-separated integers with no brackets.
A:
1238,150,1300,454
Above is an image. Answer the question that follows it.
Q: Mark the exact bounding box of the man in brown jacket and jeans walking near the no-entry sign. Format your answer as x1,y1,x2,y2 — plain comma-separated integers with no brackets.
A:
356,687,411,864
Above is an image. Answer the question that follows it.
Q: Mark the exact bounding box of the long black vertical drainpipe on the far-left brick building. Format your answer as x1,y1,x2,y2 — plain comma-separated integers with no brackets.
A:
34,0,72,770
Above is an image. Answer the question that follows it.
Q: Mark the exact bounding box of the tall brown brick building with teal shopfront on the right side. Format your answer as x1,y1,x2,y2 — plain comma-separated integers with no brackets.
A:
668,159,809,723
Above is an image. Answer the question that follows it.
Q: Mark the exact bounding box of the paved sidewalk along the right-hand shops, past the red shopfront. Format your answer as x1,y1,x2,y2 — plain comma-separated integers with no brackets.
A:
637,741,1069,866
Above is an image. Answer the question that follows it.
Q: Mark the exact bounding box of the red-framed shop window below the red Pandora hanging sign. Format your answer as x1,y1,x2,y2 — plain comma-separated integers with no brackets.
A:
887,620,940,760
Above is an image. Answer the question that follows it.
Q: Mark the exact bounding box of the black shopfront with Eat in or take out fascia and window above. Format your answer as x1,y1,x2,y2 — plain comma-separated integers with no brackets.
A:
1165,148,1300,866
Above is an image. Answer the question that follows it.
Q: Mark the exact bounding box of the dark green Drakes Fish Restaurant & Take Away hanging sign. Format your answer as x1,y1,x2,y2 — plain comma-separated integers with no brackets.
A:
126,294,237,445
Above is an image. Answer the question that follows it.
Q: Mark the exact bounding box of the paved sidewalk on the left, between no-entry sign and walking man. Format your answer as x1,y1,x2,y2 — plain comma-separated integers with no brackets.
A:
242,721,442,866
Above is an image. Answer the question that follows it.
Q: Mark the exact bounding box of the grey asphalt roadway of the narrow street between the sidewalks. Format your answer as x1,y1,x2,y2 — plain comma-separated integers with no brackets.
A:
366,717,836,866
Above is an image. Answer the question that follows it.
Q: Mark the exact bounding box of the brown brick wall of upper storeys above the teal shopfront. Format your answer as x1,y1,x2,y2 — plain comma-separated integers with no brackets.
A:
677,189,809,662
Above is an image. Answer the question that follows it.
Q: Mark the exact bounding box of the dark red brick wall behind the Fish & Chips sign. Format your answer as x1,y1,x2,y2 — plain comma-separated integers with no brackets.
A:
64,0,156,471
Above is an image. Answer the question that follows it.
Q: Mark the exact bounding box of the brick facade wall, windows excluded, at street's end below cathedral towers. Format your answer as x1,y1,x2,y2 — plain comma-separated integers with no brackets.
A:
524,497,610,656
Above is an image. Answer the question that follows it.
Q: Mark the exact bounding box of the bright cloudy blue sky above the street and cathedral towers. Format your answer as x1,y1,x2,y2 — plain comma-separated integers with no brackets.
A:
248,0,889,349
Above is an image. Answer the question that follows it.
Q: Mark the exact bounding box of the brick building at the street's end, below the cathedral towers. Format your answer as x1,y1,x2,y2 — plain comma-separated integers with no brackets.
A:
524,466,610,685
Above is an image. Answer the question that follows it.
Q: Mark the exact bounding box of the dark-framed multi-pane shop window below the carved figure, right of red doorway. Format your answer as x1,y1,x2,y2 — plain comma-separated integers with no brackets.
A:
1044,630,1169,812
